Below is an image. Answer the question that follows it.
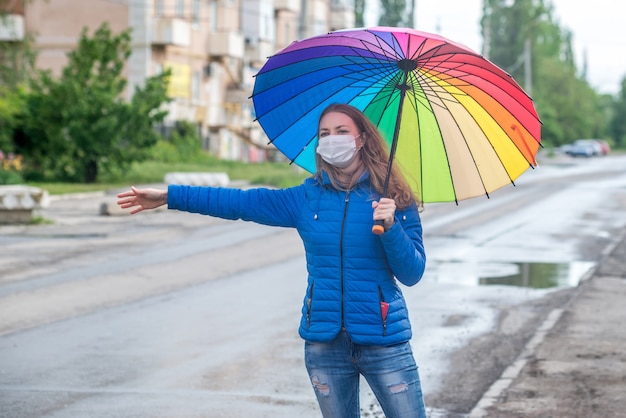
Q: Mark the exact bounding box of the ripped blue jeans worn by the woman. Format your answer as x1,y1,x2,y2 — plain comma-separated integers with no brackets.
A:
304,331,426,418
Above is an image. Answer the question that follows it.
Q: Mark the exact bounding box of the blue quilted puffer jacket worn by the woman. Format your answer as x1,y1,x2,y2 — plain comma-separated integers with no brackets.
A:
167,174,426,346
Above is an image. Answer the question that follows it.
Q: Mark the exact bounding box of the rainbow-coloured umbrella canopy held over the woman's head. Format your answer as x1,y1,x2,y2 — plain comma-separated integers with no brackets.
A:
252,27,541,203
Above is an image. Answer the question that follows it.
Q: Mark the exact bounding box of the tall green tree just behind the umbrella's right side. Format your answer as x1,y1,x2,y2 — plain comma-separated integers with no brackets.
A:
481,0,606,146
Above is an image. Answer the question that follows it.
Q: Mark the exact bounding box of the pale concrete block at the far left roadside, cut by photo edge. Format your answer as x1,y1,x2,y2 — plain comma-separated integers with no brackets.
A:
0,184,50,224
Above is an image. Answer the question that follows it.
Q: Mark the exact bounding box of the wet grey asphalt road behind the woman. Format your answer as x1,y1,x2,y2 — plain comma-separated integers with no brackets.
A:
0,153,626,418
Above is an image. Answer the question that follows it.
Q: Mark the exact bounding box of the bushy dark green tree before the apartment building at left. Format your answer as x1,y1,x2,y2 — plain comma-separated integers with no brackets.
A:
18,24,169,183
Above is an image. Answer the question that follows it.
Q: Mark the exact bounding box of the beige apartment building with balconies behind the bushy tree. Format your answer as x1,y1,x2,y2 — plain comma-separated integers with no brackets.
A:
0,0,354,161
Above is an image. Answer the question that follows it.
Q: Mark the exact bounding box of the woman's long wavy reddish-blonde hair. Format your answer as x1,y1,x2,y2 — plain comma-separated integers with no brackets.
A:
314,103,418,209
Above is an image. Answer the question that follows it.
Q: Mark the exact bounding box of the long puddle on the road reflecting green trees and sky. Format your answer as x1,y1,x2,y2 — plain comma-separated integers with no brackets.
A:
425,261,594,289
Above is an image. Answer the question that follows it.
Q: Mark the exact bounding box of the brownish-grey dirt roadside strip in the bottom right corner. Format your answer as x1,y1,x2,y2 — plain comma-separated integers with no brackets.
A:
470,231,626,418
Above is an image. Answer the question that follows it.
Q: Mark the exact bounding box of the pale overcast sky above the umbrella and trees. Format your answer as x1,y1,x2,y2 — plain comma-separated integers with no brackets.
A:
366,0,626,94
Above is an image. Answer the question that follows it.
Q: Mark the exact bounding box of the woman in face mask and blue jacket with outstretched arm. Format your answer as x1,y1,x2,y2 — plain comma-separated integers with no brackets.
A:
118,104,426,418
